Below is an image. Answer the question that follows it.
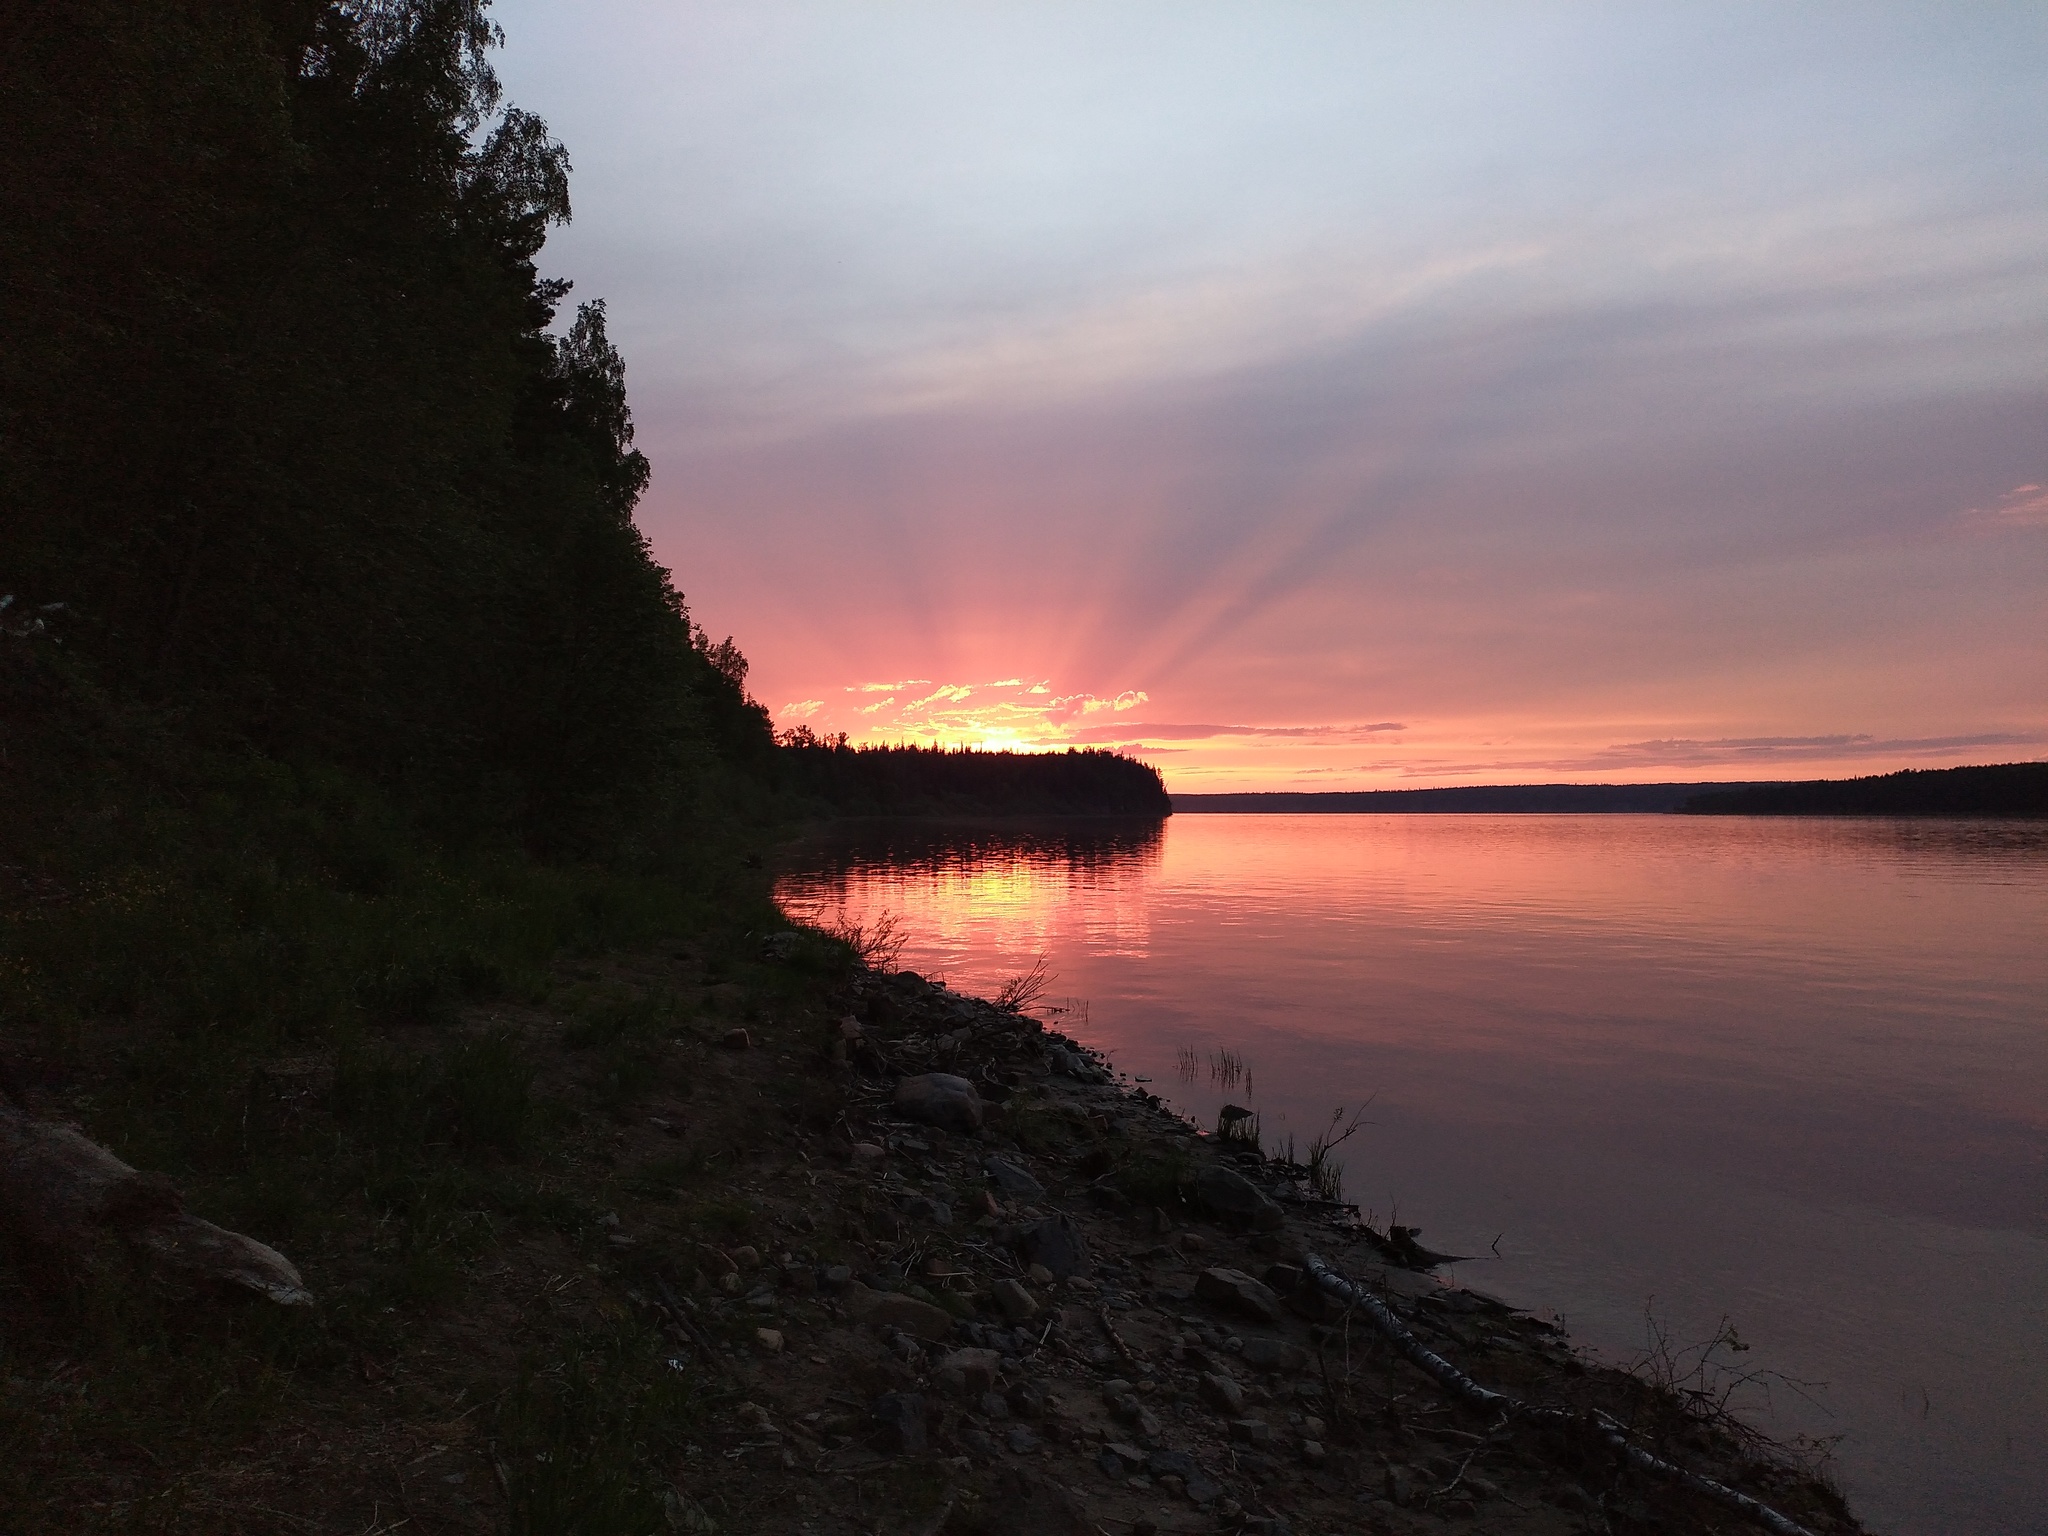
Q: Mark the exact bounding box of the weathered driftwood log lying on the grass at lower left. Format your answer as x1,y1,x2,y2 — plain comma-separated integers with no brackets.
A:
0,1094,313,1307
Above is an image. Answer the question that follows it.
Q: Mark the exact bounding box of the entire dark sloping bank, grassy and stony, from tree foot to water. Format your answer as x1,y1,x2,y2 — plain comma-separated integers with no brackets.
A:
0,930,1860,1536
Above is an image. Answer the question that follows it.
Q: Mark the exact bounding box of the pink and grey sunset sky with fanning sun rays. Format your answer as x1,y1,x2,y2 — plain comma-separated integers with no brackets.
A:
496,0,2048,791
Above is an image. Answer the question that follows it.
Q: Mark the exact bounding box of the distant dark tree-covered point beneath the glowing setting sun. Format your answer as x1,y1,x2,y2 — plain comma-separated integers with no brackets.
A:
778,741,1171,817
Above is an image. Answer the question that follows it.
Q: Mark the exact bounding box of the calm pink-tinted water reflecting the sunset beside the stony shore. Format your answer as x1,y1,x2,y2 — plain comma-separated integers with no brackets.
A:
780,815,2048,1536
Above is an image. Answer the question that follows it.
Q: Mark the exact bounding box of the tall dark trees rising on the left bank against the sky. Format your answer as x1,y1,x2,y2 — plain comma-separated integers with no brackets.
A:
0,0,768,846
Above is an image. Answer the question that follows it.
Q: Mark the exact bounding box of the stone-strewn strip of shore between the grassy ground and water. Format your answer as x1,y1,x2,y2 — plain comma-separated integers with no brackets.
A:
657,973,1858,1536
